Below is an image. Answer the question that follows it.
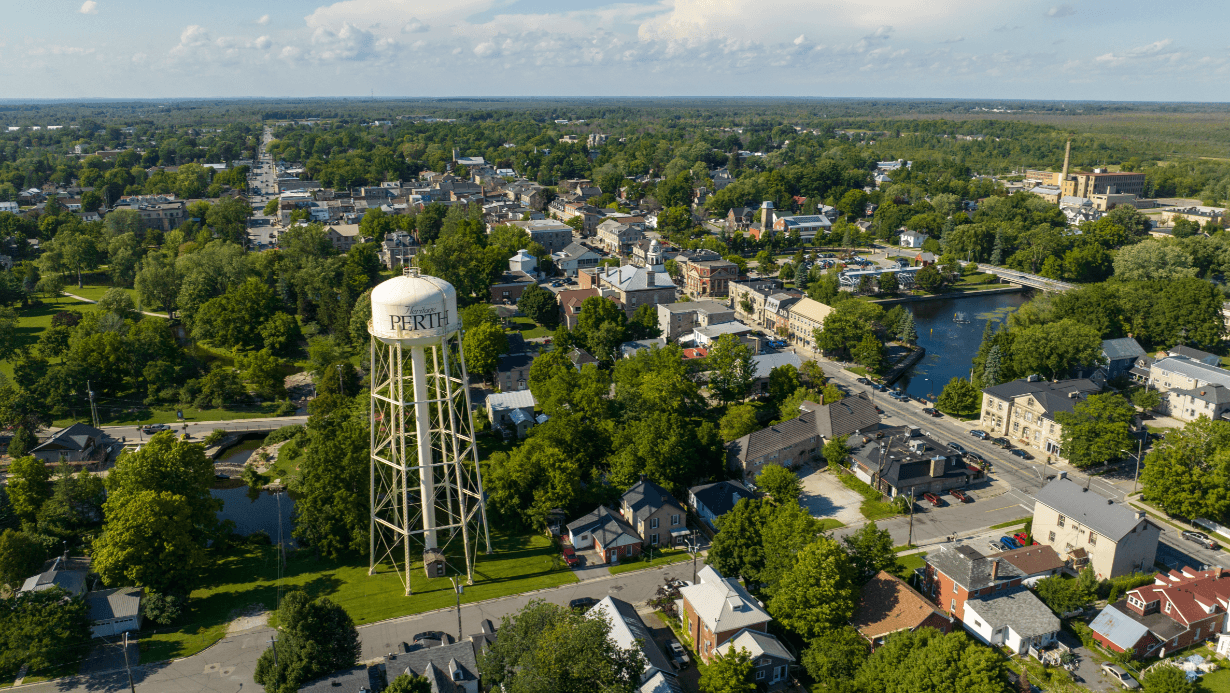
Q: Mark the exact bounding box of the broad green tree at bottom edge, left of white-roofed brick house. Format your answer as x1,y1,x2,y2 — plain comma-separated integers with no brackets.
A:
478,599,645,693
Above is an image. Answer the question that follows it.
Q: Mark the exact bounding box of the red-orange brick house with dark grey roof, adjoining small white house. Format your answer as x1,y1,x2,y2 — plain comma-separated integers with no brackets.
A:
921,544,1025,620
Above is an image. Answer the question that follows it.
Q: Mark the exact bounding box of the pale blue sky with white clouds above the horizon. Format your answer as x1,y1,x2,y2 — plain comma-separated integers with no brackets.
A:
0,0,1230,101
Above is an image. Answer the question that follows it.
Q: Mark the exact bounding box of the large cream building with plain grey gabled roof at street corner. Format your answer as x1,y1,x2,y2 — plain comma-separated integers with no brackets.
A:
1032,471,1161,579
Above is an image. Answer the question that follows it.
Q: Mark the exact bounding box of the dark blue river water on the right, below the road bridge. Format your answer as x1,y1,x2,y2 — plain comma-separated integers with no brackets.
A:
895,293,1031,398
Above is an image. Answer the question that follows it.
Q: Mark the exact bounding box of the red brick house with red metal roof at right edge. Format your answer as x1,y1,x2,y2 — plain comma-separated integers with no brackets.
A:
1090,567,1230,657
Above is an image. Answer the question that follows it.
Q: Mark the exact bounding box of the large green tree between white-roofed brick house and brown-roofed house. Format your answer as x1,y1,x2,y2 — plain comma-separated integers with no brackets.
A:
769,538,859,639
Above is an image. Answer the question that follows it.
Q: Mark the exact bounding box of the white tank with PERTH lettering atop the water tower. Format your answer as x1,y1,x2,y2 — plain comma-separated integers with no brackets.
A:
368,268,461,346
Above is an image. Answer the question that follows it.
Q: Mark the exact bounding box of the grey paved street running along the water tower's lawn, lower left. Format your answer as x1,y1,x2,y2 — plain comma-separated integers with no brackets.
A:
22,563,691,693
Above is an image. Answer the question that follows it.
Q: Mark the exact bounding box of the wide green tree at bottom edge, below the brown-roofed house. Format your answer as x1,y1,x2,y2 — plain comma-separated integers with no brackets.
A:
855,628,1011,693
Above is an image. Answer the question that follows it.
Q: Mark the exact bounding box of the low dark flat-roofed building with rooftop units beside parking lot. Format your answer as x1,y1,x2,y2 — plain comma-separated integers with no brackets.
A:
847,426,984,499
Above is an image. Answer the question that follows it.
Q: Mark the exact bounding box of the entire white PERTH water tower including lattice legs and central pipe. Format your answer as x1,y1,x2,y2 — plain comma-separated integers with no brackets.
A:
368,268,491,595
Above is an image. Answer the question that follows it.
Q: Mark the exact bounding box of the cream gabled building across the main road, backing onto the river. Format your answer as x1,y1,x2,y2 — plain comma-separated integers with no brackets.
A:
982,378,1100,458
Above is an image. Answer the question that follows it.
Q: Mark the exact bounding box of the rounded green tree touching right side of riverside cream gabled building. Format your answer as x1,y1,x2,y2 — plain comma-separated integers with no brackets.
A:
1055,394,1135,468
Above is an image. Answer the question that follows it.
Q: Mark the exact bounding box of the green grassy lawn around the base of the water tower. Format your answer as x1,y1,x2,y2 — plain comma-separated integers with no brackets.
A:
140,531,577,662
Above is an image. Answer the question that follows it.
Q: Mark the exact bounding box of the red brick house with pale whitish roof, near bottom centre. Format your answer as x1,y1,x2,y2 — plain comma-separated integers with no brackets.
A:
675,565,772,663
